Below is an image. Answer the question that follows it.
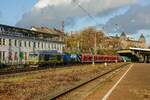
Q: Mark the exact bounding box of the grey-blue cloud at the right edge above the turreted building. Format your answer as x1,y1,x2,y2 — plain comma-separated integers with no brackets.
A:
105,4,150,34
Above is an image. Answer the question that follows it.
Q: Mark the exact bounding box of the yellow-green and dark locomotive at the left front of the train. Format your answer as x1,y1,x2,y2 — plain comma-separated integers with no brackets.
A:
28,50,63,65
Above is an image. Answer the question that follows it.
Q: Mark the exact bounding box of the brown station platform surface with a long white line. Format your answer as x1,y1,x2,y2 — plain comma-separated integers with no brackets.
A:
86,64,150,100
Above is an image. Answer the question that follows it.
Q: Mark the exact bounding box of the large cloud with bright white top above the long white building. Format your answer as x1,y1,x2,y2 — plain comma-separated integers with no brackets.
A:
16,0,136,27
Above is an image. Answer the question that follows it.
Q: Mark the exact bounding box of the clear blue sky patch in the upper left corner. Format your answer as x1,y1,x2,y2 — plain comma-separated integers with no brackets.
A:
0,0,37,25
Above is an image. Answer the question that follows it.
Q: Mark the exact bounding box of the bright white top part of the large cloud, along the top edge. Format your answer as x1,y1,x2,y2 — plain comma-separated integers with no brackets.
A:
34,0,136,10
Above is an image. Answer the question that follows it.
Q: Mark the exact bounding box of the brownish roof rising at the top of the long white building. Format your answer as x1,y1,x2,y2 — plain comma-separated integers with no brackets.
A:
31,26,64,36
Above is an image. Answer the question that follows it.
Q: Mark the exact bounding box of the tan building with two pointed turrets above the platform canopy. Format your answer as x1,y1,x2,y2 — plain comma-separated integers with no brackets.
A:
98,33,147,50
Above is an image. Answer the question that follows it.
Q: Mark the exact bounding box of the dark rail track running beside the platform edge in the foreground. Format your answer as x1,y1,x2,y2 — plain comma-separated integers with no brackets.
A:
49,63,129,100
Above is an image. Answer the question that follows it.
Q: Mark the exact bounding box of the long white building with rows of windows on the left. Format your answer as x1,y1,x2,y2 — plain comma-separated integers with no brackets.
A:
0,25,65,64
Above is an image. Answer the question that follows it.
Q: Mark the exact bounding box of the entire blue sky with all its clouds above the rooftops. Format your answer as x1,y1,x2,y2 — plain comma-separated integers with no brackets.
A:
0,0,150,45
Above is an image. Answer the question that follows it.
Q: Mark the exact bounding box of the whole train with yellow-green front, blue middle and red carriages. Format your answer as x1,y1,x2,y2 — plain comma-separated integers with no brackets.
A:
27,50,123,66
